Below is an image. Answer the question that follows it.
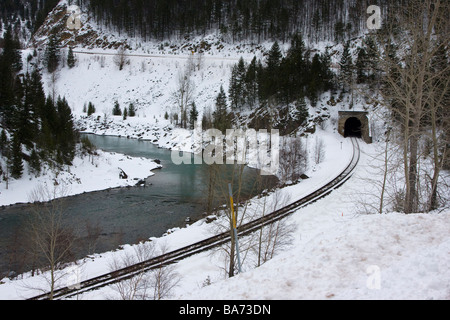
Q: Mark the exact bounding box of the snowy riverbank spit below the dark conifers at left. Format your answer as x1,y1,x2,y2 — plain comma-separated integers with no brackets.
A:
0,150,161,206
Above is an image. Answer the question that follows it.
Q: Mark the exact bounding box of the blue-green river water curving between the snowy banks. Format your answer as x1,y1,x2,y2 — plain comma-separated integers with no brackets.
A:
0,135,276,276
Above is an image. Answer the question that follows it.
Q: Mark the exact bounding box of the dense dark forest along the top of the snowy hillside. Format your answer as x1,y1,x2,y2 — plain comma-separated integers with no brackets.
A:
84,0,403,42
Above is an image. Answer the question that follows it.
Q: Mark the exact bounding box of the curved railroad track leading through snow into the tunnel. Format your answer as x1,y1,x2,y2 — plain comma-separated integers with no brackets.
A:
29,138,360,300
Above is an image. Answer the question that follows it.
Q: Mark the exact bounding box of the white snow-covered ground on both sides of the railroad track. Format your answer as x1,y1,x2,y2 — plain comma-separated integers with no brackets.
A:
0,132,450,300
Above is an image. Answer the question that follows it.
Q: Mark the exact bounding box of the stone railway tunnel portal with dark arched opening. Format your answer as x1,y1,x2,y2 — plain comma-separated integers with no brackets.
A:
338,111,372,143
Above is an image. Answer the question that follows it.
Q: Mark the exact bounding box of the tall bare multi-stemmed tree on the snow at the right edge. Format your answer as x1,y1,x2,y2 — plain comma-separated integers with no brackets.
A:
372,0,450,213
